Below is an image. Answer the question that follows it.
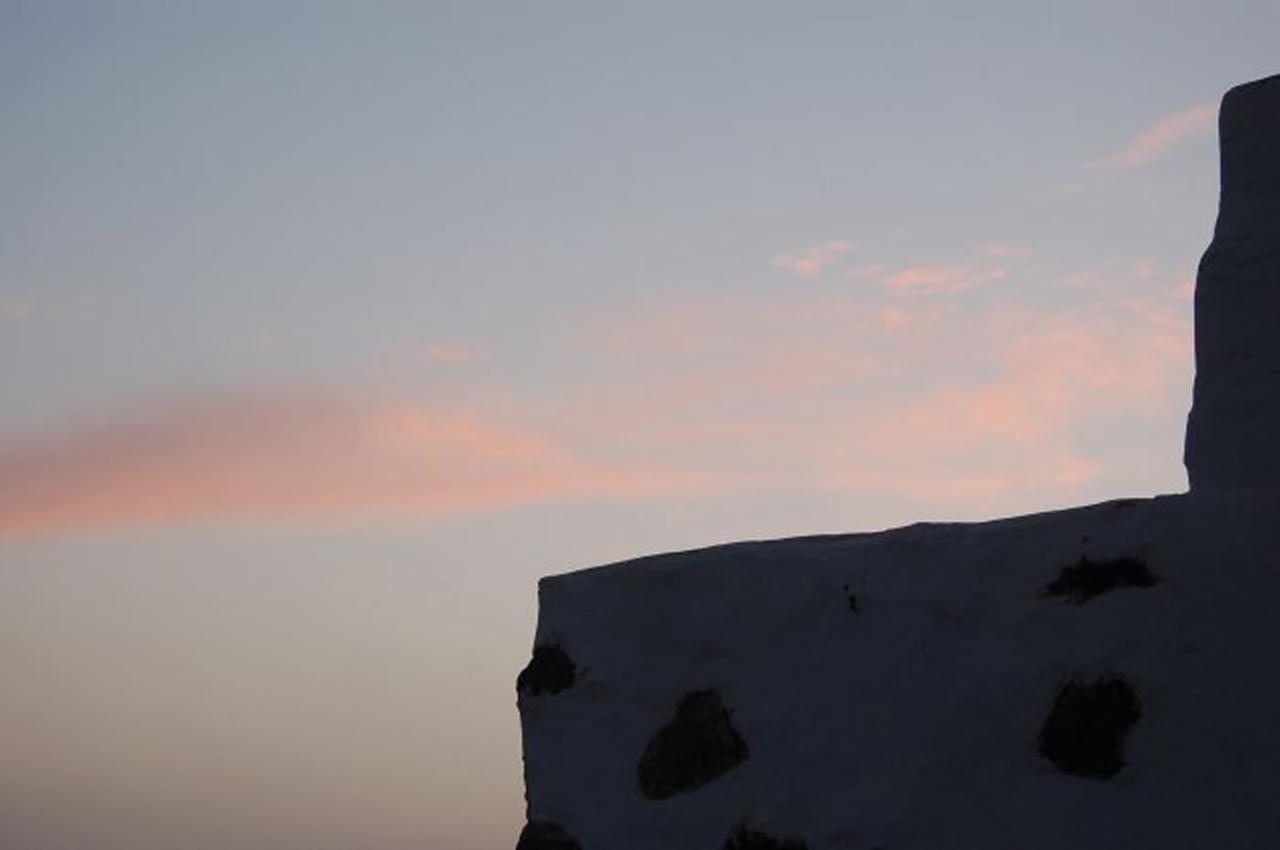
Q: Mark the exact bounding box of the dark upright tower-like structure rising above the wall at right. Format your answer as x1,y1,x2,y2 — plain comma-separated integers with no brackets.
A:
1185,76,1280,493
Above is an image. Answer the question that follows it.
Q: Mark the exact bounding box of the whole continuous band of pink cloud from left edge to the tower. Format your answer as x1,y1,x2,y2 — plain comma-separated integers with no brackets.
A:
0,256,1190,534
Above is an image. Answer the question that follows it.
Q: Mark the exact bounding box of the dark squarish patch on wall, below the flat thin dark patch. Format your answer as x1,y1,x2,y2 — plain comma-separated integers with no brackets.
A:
1039,676,1142,780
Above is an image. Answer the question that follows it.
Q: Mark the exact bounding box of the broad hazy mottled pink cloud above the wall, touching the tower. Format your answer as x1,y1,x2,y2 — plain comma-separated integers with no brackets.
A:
588,279,1190,512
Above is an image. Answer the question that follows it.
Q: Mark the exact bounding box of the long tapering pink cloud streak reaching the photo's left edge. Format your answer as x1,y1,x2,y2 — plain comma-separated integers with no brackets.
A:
0,396,695,534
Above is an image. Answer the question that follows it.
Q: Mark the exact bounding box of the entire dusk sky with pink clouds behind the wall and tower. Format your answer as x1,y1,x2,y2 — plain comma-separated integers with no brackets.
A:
0,0,1280,850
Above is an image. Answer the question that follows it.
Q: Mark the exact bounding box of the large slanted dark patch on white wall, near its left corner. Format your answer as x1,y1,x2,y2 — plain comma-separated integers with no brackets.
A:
636,690,749,800
